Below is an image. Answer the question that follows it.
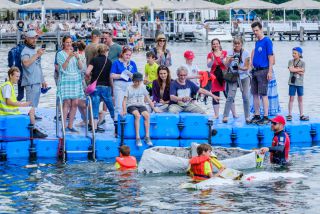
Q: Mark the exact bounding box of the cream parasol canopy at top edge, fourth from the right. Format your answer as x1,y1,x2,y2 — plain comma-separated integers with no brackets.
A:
117,0,176,10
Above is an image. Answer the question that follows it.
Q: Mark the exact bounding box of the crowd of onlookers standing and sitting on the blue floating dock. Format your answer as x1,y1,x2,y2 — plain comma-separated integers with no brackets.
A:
1,22,309,150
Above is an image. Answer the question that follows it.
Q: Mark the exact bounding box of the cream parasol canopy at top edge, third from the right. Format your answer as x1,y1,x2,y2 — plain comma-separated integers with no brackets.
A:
172,0,225,10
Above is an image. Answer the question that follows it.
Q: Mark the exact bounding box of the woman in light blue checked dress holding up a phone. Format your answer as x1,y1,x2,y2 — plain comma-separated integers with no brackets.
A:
57,36,83,133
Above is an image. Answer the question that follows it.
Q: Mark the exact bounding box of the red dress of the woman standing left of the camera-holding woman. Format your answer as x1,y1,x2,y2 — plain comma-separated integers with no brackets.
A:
207,51,227,92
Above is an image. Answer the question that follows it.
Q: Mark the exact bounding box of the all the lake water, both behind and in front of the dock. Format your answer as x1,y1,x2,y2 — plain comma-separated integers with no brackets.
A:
0,42,320,213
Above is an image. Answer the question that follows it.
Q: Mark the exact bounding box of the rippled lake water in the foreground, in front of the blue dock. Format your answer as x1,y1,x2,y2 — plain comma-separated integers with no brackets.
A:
0,147,320,213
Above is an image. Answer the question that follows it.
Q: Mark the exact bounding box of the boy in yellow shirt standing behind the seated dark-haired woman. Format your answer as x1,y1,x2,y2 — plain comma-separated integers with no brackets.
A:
143,51,159,96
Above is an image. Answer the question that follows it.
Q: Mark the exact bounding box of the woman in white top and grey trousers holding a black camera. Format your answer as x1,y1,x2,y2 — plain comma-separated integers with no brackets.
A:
222,38,250,123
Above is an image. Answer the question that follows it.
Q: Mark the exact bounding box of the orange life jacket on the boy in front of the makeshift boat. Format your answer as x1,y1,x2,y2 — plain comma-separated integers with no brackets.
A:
189,156,212,181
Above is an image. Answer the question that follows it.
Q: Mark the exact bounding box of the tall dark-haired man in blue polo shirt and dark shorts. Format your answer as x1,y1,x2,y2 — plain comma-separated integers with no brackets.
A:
250,22,274,125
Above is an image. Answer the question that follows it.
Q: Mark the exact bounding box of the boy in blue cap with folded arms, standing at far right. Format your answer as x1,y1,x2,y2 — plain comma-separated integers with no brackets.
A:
286,47,309,121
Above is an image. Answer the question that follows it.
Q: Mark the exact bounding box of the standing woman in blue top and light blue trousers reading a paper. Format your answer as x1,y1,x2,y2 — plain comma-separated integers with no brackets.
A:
111,46,138,134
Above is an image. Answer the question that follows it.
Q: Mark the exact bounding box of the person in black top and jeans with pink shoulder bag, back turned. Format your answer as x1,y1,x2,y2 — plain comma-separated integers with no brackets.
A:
86,44,114,132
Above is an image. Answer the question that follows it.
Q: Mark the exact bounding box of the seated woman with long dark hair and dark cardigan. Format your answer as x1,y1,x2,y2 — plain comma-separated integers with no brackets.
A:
152,65,171,112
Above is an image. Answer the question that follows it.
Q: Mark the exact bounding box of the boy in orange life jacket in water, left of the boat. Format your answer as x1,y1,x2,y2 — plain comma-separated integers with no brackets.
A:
114,145,138,171
